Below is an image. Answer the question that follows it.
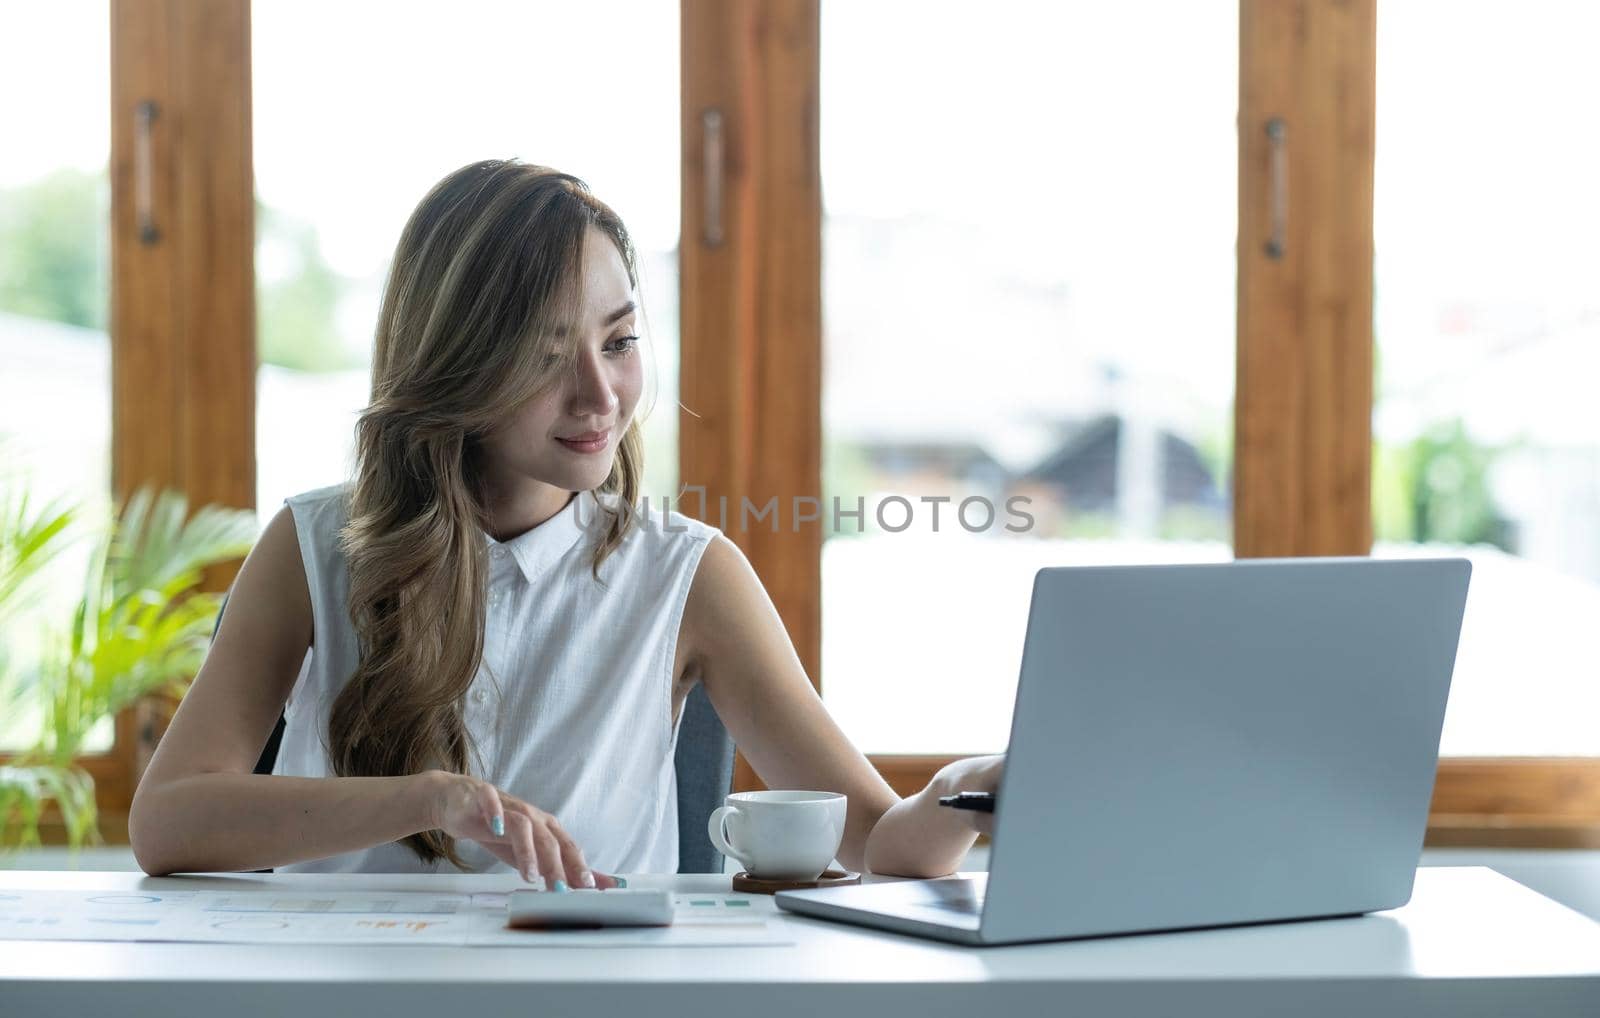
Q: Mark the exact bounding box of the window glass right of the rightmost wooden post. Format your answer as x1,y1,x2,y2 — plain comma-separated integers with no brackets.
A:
1373,0,1600,755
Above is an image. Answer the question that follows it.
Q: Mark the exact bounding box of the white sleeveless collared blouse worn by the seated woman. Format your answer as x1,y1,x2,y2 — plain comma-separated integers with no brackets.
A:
272,485,717,872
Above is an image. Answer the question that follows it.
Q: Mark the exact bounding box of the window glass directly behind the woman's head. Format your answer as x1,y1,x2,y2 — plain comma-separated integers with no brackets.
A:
251,0,678,520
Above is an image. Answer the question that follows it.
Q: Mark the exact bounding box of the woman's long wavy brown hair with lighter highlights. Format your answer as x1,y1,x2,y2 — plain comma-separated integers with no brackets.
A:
328,160,643,869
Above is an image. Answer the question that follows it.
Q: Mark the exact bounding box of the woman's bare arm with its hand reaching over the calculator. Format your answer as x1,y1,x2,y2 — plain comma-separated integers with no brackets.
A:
128,507,595,887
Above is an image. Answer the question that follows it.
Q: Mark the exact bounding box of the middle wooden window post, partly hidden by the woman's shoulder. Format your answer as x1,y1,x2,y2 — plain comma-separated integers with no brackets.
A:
678,0,822,788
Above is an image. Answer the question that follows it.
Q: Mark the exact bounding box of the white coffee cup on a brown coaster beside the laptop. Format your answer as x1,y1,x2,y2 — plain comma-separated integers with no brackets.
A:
707,791,846,880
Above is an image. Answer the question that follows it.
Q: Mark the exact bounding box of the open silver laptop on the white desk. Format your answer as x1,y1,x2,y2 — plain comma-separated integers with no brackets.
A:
776,559,1470,944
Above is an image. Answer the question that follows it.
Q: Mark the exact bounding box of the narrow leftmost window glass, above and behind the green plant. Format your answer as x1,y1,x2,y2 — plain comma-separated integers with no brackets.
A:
0,0,112,752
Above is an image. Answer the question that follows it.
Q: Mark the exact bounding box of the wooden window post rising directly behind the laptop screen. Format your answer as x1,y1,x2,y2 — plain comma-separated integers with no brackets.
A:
1234,0,1376,557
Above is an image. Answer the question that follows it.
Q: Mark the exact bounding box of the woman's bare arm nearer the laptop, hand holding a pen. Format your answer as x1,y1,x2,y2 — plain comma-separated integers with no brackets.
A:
680,533,1002,877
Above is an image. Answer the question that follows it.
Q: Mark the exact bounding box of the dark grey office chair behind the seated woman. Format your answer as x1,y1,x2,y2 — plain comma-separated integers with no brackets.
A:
213,595,733,872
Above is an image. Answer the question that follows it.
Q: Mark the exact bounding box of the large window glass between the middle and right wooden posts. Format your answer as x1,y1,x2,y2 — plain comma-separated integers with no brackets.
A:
821,0,1238,752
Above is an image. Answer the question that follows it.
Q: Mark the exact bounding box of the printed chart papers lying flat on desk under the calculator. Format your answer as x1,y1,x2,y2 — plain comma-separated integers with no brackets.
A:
0,890,794,948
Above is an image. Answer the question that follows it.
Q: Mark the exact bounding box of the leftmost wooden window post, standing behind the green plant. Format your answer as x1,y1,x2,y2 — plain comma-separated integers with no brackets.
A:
106,0,256,809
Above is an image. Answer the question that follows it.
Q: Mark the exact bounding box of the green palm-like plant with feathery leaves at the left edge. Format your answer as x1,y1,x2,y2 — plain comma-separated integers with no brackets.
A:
0,483,256,855
